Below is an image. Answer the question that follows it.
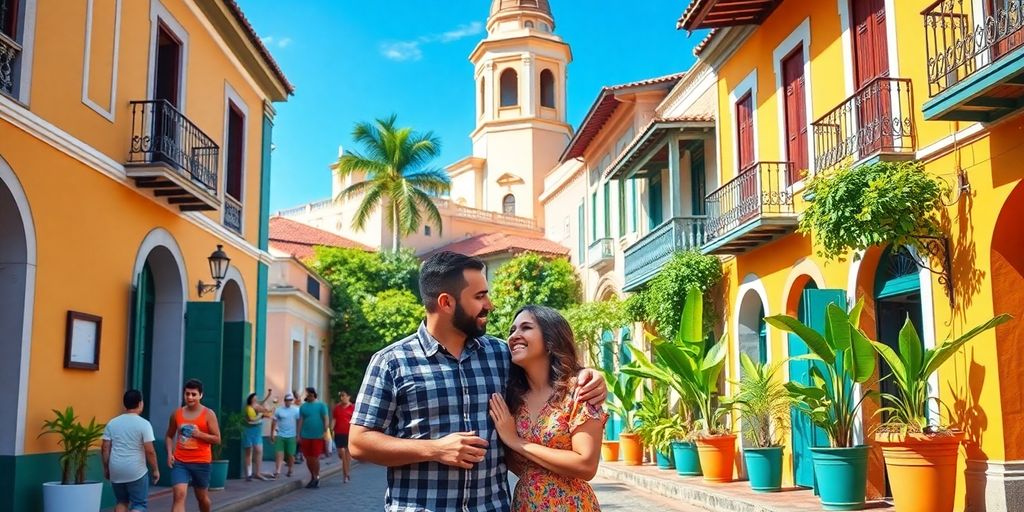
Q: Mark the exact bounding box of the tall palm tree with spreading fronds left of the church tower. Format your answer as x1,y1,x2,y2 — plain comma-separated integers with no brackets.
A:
335,114,452,252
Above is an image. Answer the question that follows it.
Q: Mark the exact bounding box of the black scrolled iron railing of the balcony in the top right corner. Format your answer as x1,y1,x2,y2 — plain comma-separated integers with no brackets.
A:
922,0,1024,96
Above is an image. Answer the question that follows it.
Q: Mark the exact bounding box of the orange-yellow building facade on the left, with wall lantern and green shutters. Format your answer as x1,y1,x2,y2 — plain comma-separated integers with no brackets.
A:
0,0,292,511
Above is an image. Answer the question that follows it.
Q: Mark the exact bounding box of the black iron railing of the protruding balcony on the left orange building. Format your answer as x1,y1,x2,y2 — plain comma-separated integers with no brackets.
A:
128,99,220,191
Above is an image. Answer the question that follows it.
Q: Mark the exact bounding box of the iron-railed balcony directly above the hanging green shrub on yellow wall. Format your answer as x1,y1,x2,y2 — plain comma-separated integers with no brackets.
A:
811,77,918,174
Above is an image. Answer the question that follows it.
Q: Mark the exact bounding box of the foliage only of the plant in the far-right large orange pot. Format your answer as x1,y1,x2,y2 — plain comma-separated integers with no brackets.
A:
871,314,1013,434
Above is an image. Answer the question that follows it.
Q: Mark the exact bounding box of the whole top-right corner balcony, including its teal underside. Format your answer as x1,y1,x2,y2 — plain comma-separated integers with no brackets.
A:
922,0,1024,122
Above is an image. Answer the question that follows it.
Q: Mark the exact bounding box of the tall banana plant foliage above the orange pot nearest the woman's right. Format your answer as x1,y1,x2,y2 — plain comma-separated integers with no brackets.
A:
622,287,732,436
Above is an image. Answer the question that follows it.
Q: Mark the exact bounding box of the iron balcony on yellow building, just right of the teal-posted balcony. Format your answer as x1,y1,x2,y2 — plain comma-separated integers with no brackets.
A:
702,162,797,254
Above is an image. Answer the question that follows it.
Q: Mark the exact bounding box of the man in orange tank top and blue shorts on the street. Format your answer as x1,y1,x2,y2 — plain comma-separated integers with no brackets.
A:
164,379,220,512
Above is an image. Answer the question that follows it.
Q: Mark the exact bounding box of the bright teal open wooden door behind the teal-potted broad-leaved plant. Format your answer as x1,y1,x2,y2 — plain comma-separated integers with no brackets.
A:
788,285,846,487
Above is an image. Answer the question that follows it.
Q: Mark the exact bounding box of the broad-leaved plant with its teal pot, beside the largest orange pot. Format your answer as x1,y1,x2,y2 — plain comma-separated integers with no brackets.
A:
765,300,878,510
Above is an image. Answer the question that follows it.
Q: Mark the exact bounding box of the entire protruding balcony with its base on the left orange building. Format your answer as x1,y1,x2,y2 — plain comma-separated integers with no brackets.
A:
125,99,220,211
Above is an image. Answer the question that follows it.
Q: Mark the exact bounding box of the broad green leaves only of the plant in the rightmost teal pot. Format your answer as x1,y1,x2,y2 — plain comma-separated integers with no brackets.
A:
765,299,878,447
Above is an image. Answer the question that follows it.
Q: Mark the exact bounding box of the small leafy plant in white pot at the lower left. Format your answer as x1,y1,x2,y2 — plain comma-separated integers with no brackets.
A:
39,406,104,512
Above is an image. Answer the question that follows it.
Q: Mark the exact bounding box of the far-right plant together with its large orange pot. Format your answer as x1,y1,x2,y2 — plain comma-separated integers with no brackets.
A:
871,314,1011,512
